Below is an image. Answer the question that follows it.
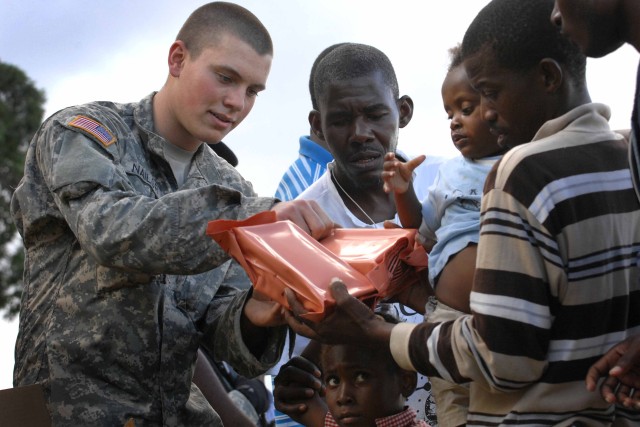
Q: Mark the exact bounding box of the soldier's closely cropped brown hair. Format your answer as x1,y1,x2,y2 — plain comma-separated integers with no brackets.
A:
176,2,273,57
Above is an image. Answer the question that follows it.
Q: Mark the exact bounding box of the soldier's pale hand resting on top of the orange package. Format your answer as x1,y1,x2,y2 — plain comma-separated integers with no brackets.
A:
271,200,338,240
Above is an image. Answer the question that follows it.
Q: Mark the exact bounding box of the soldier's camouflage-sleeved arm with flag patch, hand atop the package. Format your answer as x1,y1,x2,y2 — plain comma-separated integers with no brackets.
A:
41,110,333,275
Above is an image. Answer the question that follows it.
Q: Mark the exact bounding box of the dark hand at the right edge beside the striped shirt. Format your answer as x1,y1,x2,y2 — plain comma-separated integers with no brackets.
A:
586,334,640,409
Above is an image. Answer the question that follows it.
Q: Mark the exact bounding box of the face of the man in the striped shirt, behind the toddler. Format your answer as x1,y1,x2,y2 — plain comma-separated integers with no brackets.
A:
463,52,549,148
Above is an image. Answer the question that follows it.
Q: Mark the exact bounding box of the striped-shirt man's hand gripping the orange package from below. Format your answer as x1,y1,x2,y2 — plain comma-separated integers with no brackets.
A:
285,279,393,347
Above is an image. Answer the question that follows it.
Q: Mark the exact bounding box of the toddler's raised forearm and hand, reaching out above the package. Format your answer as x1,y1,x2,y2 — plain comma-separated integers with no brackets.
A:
382,153,426,228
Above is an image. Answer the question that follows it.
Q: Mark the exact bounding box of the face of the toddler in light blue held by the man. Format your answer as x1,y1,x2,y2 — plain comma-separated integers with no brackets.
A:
442,65,502,159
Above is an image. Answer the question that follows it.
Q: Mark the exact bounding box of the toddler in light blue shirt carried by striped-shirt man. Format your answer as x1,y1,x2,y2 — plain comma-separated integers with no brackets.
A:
383,47,504,427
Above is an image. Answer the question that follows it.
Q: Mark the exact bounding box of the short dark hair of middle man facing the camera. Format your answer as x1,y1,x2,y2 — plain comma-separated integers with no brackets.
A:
314,43,400,109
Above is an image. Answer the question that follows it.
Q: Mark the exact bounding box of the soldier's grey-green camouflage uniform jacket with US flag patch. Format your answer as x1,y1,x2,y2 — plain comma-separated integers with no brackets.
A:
11,94,285,427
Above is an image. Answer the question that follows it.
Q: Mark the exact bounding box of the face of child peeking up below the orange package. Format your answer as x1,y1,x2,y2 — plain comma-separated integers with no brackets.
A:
321,345,416,427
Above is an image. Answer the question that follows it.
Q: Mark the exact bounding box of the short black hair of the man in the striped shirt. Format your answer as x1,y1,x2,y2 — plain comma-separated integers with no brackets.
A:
462,0,586,85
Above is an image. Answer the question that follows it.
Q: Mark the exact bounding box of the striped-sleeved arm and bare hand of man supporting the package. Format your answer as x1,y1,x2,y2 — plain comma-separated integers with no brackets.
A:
286,172,562,390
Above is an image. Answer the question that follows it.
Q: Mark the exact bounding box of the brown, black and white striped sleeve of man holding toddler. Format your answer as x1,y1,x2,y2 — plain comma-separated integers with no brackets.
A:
400,175,565,391
